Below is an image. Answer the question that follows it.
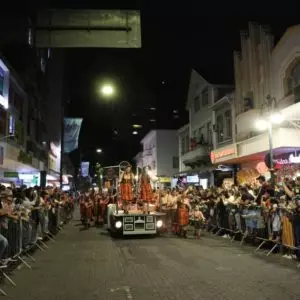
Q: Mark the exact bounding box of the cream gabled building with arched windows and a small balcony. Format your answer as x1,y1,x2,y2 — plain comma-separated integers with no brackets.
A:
178,70,234,185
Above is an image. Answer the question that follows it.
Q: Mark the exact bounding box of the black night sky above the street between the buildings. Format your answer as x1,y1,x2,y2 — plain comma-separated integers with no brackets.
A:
5,0,300,165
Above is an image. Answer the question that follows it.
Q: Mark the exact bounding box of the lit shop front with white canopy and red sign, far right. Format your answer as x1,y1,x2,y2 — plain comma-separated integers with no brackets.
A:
211,128,300,184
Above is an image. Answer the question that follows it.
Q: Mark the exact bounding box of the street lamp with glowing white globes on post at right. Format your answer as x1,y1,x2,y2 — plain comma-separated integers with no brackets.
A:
256,96,284,187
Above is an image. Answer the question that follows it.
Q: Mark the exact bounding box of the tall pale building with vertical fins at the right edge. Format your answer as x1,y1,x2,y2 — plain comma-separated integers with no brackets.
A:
211,23,300,183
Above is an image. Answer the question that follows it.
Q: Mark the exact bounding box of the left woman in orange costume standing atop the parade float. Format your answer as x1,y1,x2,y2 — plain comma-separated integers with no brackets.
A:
119,166,134,213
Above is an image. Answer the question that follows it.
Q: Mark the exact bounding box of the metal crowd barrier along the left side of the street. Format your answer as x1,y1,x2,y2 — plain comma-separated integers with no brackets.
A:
0,206,73,296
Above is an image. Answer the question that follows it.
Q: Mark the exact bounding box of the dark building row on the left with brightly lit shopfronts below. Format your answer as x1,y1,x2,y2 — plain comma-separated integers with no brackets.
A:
0,15,66,186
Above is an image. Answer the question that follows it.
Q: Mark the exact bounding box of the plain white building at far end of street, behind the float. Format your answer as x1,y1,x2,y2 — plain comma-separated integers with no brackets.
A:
135,130,179,182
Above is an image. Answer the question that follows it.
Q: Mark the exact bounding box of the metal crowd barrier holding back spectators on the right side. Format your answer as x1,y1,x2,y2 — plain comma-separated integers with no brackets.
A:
203,206,300,257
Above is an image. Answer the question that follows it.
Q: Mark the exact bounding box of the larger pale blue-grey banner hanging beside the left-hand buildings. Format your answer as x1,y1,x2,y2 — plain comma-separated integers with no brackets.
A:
64,118,83,153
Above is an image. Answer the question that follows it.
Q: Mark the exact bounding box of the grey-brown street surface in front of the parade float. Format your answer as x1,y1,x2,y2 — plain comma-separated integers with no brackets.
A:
1,217,300,300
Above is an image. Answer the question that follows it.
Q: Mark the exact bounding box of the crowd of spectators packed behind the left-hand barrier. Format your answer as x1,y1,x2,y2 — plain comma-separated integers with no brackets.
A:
0,186,74,268
